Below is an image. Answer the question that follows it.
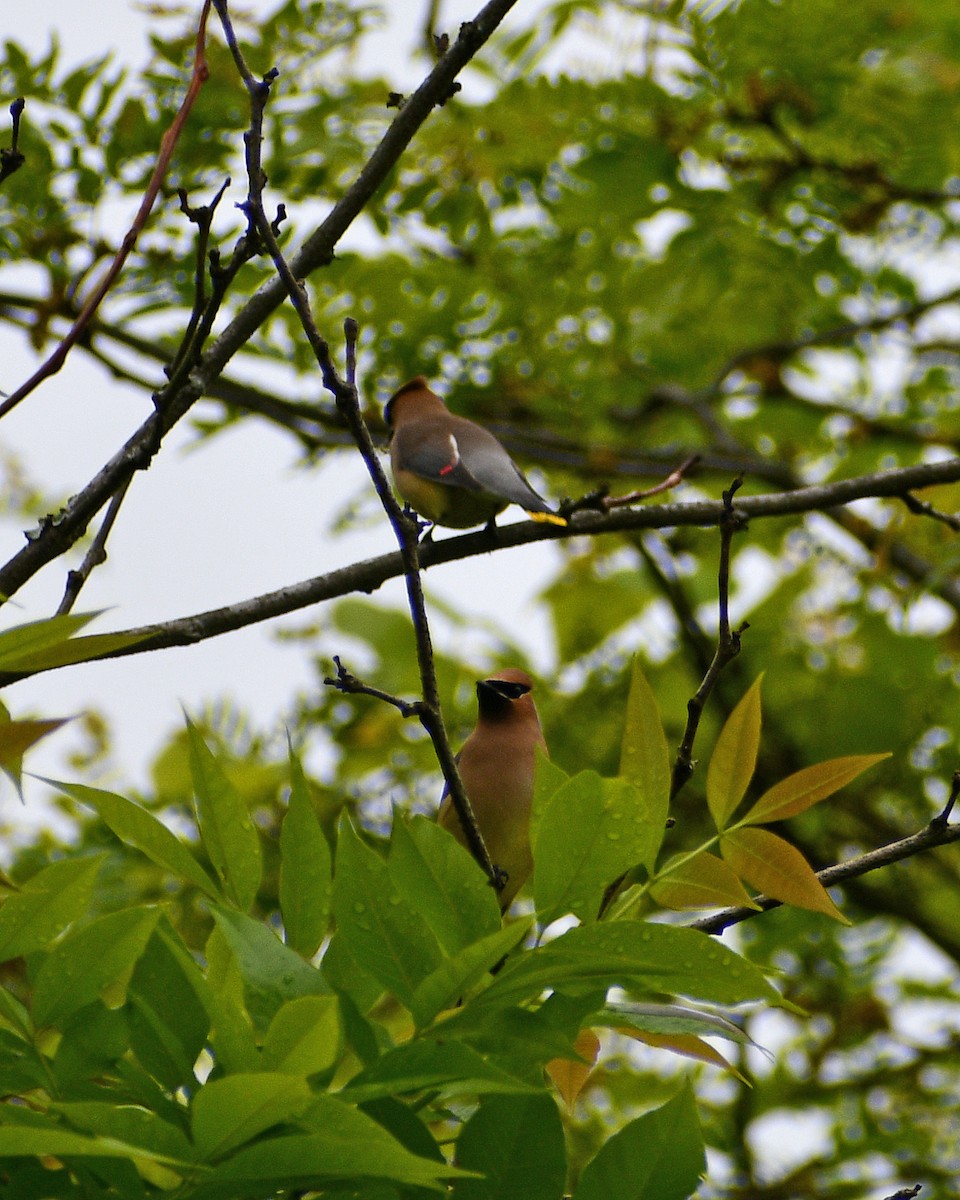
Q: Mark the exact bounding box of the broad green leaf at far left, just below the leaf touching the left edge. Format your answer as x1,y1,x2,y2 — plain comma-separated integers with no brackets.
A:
34,908,161,1026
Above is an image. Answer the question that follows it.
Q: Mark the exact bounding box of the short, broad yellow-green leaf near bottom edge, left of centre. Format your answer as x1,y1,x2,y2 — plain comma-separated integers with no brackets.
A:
191,1072,311,1163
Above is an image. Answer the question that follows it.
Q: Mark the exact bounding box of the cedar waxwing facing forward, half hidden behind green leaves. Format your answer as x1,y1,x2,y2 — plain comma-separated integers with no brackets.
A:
437,667,547,912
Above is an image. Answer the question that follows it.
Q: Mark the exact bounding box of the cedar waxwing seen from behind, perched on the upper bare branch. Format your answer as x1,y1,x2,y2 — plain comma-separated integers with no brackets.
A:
384,376,566,529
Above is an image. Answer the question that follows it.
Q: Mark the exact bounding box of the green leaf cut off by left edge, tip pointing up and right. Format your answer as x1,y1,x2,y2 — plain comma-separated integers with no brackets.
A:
0,854,107,962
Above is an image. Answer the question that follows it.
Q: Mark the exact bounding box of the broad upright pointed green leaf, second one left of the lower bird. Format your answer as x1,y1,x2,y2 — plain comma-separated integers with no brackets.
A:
334,815,444,1008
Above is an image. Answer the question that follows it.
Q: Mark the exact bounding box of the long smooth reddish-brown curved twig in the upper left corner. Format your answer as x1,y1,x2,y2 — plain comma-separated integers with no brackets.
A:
0,0,210,418
